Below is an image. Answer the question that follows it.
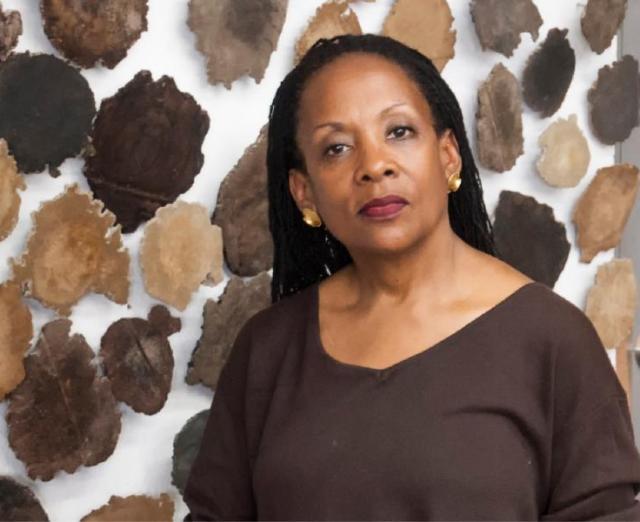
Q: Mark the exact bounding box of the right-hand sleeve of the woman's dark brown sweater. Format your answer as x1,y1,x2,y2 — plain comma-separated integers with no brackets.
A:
540,308,640,521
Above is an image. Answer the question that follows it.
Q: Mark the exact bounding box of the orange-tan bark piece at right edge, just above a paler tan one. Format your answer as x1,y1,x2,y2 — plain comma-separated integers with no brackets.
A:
572,164,640,263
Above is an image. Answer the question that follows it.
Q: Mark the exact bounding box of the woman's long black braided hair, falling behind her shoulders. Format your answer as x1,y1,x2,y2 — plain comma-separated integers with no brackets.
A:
267,34,497,303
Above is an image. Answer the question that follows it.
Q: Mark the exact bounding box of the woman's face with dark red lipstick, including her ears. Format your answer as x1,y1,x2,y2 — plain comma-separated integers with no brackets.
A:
289,53,461,255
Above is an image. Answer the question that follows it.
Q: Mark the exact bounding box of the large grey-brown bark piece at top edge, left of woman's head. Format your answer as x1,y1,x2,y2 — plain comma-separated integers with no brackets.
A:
187,0,288,89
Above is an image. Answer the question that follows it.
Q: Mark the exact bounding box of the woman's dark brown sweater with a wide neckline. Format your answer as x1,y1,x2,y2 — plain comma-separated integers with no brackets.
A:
184,282,640,520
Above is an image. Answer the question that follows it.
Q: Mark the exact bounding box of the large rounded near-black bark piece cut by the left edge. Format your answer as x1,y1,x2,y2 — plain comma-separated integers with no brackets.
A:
0,53,96,176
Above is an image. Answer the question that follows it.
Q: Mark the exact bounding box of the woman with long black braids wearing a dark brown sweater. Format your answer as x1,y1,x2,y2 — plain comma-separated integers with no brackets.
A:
184,34,640,520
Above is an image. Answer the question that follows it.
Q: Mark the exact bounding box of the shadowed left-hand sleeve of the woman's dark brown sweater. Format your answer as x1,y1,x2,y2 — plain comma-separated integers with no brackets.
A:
183,323,256,521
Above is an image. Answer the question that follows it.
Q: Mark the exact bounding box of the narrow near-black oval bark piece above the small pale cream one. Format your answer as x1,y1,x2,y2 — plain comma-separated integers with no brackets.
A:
522,29,576,118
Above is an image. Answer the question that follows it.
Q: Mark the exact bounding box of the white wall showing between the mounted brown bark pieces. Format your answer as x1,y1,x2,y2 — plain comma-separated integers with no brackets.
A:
0,0,616,521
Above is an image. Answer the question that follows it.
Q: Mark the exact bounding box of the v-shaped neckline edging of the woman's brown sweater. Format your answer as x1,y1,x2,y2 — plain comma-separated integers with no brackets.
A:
311,281,544,377
